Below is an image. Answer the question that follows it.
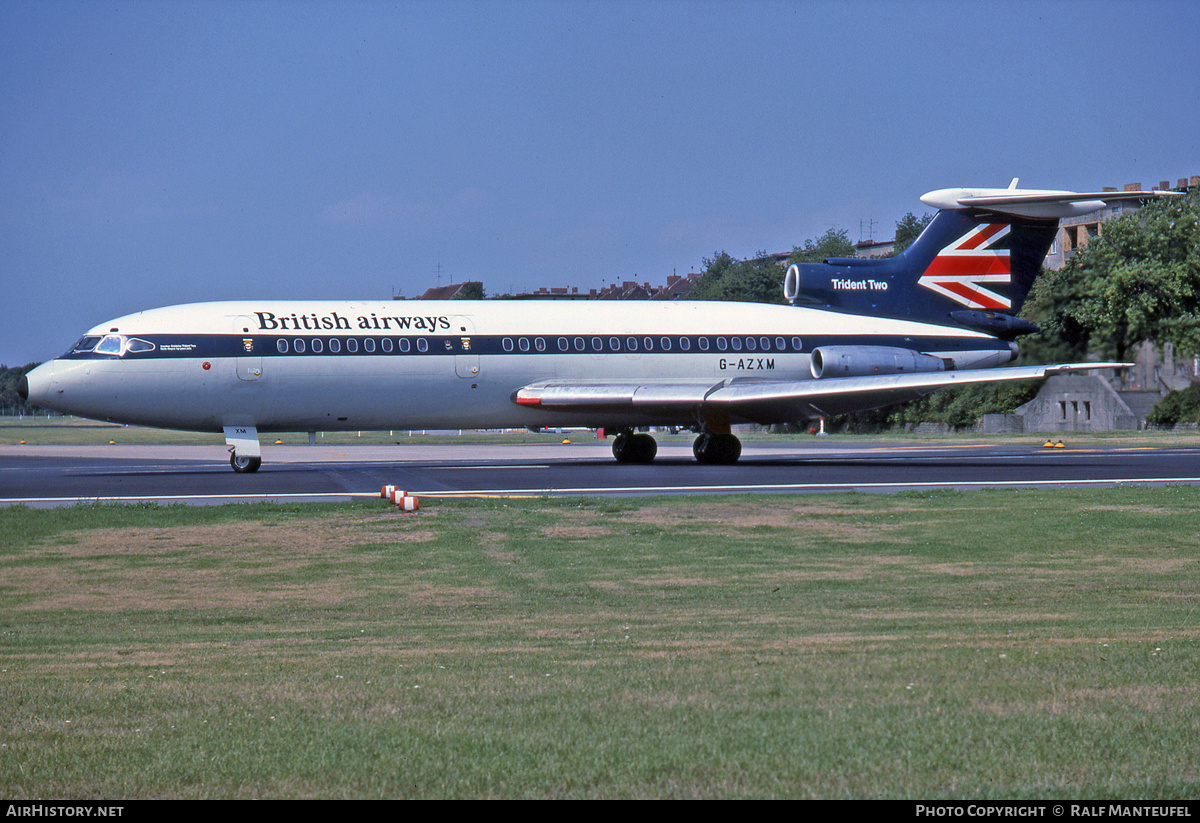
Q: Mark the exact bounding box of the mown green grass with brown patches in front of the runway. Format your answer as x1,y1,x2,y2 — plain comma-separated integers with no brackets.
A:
0,487,1200,799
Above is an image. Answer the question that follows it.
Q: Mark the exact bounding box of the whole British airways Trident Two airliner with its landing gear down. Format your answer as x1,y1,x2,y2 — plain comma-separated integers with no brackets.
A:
18,180,1172,473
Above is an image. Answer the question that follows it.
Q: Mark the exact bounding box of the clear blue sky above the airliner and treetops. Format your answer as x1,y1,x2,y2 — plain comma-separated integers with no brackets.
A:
0,0,1200,366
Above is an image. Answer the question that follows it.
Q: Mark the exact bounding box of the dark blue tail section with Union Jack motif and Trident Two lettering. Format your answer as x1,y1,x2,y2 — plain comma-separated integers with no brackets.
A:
784,180,1163,338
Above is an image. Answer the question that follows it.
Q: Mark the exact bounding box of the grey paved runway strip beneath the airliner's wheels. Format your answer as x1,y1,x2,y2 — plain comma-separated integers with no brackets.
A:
0,435,1200,506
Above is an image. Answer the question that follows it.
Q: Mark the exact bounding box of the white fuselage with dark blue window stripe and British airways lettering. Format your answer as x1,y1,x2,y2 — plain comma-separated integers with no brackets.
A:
21,300,1014,432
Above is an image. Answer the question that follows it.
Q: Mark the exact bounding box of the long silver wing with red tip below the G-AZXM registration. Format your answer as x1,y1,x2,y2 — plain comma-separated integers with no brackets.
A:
512,362,1130,423
